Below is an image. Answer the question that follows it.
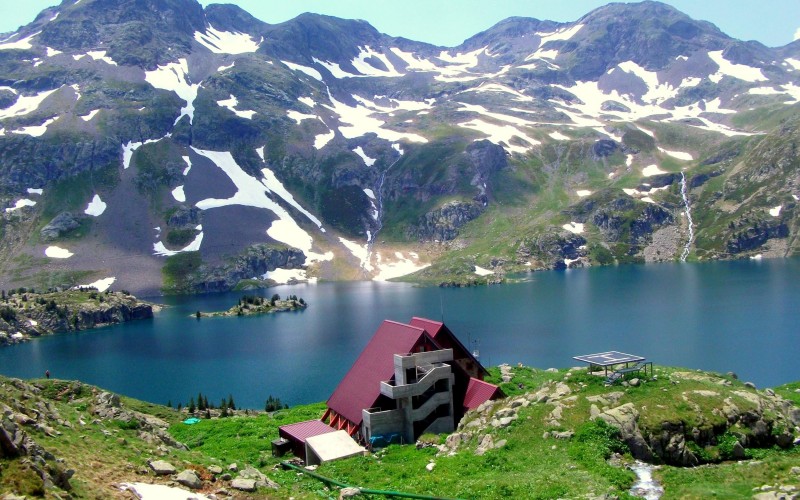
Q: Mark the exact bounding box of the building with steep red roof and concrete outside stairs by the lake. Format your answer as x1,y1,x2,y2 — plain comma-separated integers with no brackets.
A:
322,318,503,446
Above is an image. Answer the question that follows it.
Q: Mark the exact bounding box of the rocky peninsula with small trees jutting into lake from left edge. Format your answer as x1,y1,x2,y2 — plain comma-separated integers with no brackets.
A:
0,287,160,346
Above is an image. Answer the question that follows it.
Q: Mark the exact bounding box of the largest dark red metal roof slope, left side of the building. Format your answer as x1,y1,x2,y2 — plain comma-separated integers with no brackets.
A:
328,320,428,425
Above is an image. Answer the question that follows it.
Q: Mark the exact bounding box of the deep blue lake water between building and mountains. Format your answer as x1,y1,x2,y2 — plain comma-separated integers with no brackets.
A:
0,259,800,409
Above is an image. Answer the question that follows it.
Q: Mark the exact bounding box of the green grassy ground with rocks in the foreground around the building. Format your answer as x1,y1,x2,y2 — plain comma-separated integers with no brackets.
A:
0,367,800,498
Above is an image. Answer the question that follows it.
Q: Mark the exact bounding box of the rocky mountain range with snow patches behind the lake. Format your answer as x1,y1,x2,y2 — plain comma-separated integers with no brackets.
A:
0,0,800,295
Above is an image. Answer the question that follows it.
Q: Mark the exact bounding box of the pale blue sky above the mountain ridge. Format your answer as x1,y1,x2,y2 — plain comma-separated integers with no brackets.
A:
0,0,800,47
